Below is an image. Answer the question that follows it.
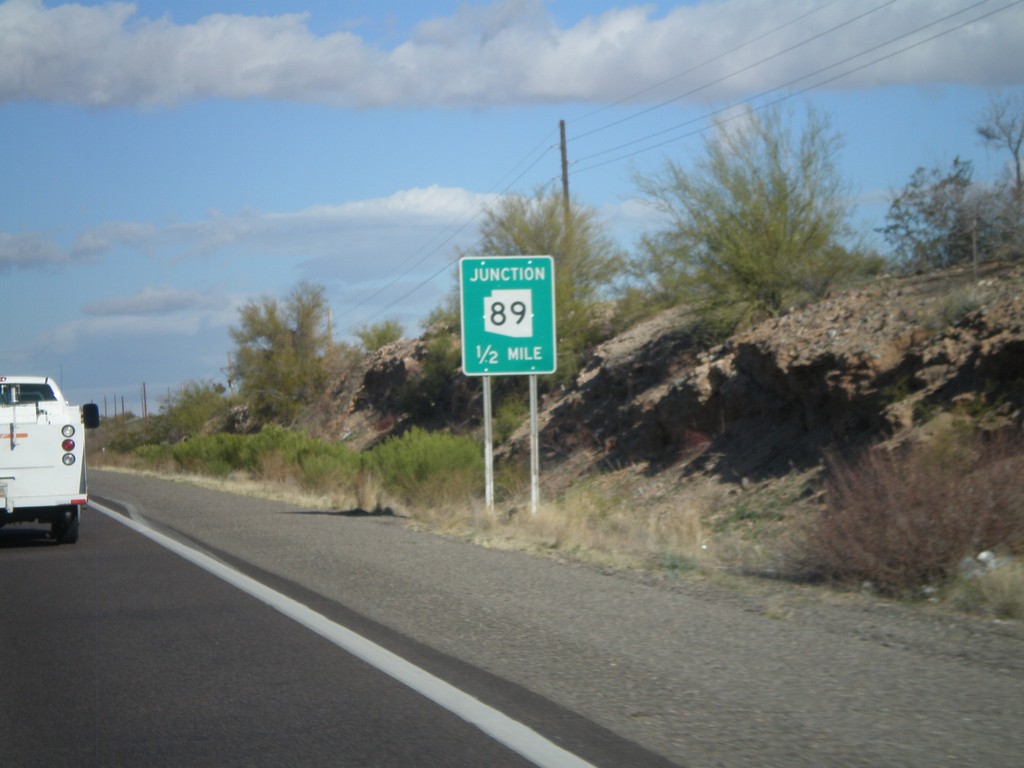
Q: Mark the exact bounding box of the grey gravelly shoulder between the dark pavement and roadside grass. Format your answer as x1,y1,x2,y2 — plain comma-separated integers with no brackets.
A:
90,470,1024,768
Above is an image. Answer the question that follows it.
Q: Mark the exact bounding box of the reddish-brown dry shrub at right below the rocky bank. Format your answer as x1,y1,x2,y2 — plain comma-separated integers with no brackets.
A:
798,430,1024,595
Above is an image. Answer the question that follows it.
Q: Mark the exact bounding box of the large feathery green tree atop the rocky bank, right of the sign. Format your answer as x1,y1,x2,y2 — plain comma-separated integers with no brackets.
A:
633,103,870,335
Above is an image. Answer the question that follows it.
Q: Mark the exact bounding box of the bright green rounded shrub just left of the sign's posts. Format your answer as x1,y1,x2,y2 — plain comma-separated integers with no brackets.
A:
365,428,483,506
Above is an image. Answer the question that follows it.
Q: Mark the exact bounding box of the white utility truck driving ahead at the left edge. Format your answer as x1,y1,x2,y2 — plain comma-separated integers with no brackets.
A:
0,376,99,544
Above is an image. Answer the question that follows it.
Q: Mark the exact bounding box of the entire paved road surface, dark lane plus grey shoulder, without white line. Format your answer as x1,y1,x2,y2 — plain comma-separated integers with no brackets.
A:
0,471,1024,767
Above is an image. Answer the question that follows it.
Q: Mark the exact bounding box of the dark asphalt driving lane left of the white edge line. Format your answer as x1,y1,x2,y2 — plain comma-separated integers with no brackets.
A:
0,513,557,767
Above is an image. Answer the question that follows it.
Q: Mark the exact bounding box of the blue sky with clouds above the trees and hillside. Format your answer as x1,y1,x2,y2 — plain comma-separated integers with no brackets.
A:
0,0,1024,412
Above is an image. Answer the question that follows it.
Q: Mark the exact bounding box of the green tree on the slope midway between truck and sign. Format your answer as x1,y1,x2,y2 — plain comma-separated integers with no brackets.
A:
230,282,331,422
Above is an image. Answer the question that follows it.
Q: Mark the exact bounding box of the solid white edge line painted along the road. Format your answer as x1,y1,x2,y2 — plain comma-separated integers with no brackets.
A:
89,501,595,768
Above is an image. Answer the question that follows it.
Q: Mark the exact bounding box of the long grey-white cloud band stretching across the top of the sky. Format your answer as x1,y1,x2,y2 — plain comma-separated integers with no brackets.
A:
0,0,1024,108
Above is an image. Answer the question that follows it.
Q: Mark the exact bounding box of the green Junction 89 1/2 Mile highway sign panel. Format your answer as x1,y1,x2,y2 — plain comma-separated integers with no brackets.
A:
459,256,556,376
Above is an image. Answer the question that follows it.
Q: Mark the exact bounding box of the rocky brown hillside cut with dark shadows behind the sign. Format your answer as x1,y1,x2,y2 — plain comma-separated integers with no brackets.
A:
319,265,1024,489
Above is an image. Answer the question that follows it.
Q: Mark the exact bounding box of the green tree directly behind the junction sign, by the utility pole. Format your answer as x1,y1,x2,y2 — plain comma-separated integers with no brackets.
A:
463,188,624,376
